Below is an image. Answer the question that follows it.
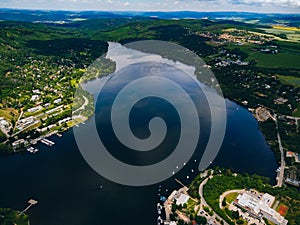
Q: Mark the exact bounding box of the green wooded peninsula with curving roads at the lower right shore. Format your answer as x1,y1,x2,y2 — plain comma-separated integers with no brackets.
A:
165,169,300,225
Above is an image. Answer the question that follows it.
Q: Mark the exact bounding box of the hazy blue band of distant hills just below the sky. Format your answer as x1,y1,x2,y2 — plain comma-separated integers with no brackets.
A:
0,9,300,27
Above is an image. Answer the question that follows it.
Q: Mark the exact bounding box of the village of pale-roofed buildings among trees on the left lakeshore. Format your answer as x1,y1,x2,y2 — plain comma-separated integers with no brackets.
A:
0,59,92,153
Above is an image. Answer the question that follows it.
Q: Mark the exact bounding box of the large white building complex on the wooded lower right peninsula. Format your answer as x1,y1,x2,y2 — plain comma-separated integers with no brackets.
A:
234,193,288,225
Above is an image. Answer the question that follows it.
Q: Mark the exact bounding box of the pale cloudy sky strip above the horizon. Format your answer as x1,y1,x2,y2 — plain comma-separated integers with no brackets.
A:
0,0,300,13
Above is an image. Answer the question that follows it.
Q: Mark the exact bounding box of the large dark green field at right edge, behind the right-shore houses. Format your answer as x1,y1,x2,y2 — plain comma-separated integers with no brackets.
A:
247,52,300,69
